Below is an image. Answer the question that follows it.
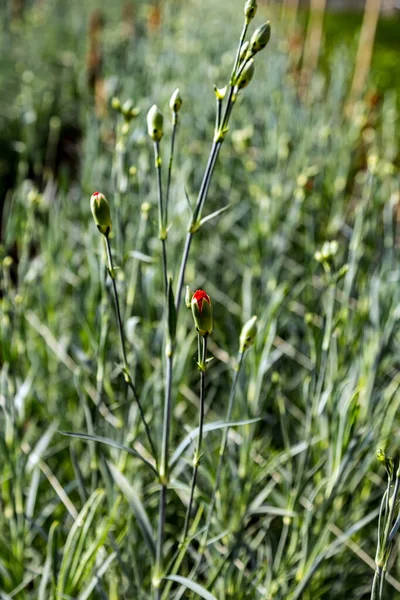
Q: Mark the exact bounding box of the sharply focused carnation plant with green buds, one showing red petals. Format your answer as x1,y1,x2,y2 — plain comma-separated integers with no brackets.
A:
66,0,271,600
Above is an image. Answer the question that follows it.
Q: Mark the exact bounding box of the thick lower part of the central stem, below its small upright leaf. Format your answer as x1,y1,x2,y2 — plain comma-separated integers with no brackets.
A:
155,351,173,600
